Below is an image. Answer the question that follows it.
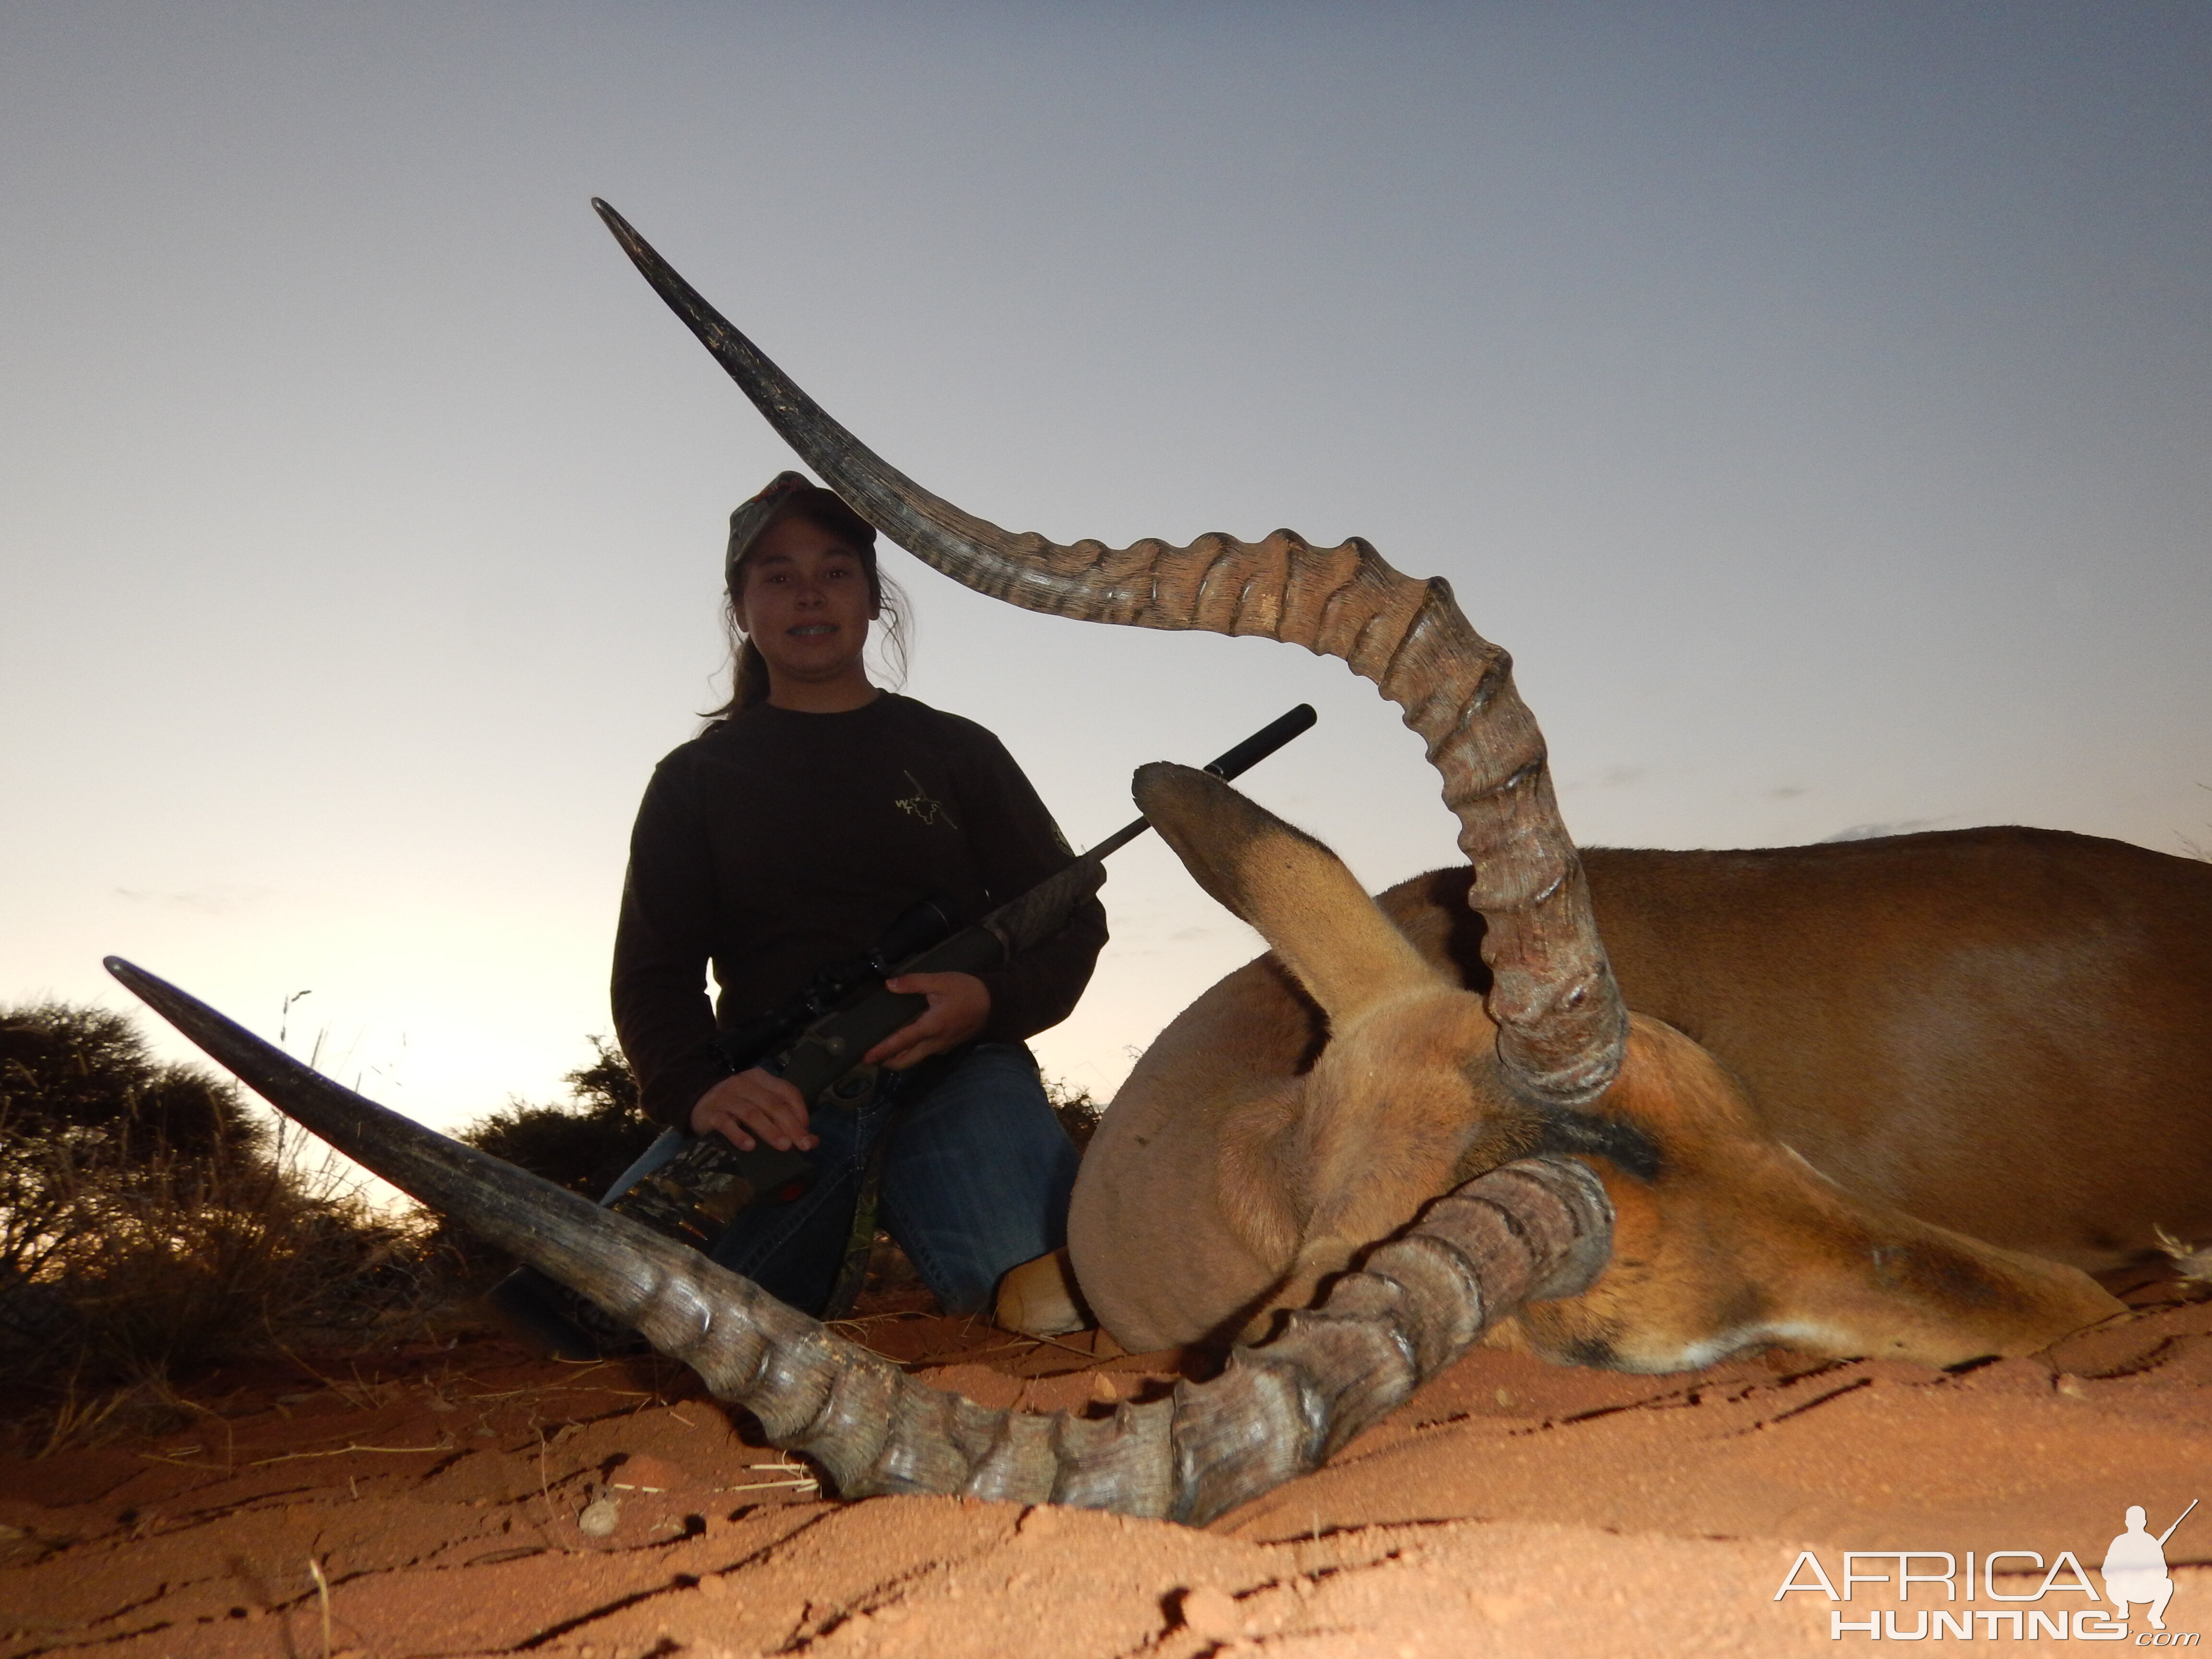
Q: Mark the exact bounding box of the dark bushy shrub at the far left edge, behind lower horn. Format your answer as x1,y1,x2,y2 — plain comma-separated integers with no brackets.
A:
0,1002,421,1433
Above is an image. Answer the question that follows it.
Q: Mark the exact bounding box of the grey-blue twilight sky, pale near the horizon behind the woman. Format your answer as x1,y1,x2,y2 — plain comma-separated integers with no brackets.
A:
0,0,2212,1126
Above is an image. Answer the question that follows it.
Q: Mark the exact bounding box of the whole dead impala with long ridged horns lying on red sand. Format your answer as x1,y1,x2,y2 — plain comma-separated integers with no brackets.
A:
110,204,2212,1522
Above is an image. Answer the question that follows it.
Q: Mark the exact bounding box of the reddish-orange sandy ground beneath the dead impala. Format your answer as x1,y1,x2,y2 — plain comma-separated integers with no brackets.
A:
0,1283,2212,1659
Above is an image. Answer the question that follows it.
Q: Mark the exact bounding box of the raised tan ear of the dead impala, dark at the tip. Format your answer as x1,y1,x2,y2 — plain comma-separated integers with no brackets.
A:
1132,761,1449,1026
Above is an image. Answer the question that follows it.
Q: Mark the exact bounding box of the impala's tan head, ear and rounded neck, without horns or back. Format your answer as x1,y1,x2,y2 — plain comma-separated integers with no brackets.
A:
1070,768,2157,1371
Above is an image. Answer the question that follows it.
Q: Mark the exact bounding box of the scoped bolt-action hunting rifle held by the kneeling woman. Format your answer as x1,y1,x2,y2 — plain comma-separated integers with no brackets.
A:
608,703,1318,1250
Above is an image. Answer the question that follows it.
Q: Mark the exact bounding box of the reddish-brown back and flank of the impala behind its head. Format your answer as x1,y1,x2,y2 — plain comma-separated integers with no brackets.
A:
1575,830,2212,1270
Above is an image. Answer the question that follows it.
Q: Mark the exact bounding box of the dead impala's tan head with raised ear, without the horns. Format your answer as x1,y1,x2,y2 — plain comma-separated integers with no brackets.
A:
1123,765,2117,1371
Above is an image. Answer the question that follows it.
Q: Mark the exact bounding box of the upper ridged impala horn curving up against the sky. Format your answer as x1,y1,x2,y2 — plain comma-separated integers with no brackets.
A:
590,197,1628,1106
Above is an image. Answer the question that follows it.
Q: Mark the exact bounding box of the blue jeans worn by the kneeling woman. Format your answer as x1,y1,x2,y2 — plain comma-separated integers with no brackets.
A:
601,1042,1075,1314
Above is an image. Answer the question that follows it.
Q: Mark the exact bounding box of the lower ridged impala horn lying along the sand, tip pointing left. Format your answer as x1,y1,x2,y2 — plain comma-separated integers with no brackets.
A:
106,956,1612,1524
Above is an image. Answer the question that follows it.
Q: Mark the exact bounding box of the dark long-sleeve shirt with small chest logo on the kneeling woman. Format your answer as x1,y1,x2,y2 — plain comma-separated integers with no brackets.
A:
613,692,1106,1126
